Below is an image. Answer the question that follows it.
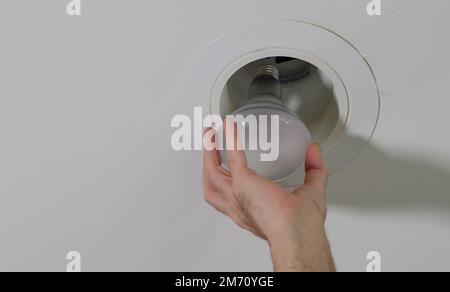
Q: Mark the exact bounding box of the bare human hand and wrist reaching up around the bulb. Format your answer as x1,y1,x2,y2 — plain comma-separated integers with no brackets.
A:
203,123,335,271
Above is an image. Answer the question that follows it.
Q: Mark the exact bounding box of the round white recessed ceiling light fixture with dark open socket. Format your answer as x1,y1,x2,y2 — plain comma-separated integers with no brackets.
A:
181,21,379,186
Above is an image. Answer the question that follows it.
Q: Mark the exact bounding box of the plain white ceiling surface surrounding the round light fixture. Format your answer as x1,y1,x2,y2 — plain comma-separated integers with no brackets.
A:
0,0,450,271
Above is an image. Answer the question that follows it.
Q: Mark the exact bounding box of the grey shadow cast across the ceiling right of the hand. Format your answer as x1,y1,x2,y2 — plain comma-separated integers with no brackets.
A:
328,135,450,216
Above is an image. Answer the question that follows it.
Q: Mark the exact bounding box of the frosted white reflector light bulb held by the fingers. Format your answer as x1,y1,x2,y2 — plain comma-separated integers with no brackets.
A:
233,65,312,181
